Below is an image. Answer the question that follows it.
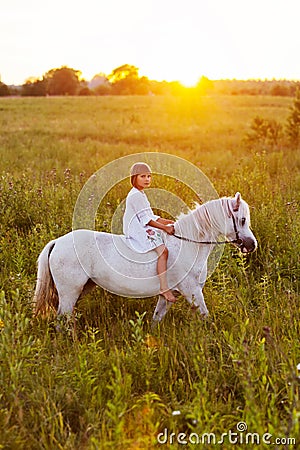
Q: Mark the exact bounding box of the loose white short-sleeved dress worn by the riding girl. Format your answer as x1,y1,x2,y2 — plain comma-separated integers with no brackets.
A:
123,187,164,253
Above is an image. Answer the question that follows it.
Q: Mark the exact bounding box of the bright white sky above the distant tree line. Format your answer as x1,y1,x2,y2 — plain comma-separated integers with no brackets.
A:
0,0,300,85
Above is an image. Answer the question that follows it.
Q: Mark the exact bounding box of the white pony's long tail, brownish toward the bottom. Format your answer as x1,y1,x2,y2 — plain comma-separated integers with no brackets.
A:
33,240,58,316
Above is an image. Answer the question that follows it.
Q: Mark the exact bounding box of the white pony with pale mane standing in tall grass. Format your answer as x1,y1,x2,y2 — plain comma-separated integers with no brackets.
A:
34,193,257,322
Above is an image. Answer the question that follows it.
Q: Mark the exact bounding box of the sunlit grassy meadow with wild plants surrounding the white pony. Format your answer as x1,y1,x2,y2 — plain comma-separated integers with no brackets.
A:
0,95,300,450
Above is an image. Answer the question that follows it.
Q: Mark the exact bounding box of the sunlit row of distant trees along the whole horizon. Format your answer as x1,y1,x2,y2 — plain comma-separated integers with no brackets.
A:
0,64,300,96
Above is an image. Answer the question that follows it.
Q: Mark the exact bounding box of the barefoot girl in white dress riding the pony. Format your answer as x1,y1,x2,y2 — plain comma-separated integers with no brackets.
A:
123,162,176,303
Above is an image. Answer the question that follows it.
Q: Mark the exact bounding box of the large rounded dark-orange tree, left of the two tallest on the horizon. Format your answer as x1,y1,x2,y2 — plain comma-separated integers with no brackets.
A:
45,66,81,95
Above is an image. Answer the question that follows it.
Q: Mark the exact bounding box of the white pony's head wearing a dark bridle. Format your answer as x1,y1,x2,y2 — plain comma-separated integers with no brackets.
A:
223,192,257,253
